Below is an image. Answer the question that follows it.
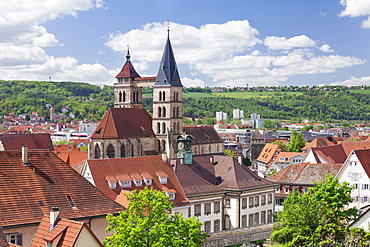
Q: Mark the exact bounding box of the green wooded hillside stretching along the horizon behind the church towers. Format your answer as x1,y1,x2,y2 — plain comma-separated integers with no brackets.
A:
0,81,370,122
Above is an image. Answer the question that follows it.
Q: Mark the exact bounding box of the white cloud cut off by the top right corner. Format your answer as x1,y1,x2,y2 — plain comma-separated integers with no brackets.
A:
339,0,370,28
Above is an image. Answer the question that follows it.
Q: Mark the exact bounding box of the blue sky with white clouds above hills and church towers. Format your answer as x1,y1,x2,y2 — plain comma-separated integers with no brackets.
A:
0,0,370,87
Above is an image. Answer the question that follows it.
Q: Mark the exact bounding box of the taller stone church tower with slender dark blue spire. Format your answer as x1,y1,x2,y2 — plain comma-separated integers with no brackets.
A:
152,31,183,158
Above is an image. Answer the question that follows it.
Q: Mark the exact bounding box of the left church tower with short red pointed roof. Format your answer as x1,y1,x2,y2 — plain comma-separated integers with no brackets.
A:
114,50,143,108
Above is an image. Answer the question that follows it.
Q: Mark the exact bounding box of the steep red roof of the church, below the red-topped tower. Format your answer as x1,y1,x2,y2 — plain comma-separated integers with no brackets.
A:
91,108,155,139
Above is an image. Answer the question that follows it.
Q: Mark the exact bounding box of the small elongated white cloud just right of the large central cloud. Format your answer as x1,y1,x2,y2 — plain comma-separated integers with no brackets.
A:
264,35,316,50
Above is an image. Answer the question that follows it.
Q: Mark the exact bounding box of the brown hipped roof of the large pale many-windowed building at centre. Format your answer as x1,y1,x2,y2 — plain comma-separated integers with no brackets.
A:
177,155,273,191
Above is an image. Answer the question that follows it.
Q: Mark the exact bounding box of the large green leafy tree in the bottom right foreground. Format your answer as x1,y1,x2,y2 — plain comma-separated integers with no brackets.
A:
271,174,357,246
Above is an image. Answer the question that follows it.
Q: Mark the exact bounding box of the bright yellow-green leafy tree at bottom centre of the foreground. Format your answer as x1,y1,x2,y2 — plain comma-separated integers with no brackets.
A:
103,187,208,247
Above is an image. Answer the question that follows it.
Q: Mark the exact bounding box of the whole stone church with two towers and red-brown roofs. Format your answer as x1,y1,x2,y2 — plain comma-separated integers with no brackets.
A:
88,30,224,159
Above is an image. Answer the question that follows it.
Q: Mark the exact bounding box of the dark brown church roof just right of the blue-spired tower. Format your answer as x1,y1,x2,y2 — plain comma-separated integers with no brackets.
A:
183,125,223,144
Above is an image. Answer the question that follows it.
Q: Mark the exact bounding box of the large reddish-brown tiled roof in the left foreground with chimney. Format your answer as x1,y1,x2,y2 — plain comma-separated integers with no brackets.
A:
0,150,123,226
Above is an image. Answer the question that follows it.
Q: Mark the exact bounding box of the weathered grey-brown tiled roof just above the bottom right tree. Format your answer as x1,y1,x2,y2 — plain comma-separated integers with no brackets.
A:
267,163,342,185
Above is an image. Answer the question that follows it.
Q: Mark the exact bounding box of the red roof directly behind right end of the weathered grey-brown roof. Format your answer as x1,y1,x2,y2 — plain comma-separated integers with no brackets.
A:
309,144,347,163
